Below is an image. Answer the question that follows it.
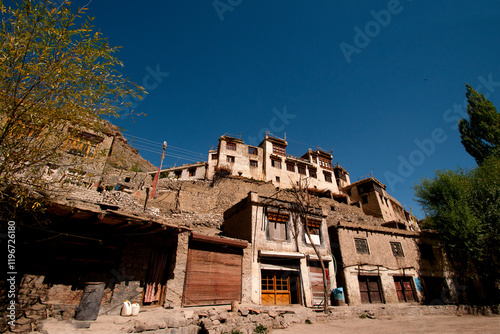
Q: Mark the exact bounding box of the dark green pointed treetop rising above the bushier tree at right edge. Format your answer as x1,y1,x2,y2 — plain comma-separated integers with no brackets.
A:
458,84,500,165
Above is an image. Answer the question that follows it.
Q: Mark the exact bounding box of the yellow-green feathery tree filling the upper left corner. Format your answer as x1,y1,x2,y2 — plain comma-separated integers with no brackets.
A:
0,0,145,219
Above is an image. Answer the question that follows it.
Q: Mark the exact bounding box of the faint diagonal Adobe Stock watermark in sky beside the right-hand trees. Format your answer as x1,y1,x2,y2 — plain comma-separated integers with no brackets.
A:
384,74,500,191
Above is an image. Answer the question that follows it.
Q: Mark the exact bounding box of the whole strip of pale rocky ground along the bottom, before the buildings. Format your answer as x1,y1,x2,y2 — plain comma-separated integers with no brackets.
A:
28,304,500,334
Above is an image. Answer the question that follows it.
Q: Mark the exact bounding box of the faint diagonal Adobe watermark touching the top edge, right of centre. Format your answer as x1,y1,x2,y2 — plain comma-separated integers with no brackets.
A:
339,0,411,64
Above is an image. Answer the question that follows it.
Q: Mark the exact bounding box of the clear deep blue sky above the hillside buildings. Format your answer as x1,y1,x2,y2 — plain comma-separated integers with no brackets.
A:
78,0,500,218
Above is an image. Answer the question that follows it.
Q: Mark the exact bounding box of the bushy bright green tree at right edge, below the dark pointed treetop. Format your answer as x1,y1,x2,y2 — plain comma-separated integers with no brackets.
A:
415,155,500,302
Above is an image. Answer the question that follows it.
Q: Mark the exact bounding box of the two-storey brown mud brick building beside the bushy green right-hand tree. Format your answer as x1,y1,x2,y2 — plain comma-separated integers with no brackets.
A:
329,222,456,305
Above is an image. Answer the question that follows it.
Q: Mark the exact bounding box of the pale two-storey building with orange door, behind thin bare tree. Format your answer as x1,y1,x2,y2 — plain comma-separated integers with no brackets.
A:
223,192,335,306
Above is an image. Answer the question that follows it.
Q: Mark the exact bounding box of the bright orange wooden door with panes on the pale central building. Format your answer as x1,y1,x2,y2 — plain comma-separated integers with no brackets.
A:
261,270,291,305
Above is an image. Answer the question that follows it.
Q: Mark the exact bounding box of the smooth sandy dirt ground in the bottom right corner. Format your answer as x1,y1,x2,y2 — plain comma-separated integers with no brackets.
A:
272,315,500,334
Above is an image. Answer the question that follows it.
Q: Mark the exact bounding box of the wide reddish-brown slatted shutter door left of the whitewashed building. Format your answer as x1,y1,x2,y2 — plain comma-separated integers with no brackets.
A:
182,242,243,306
